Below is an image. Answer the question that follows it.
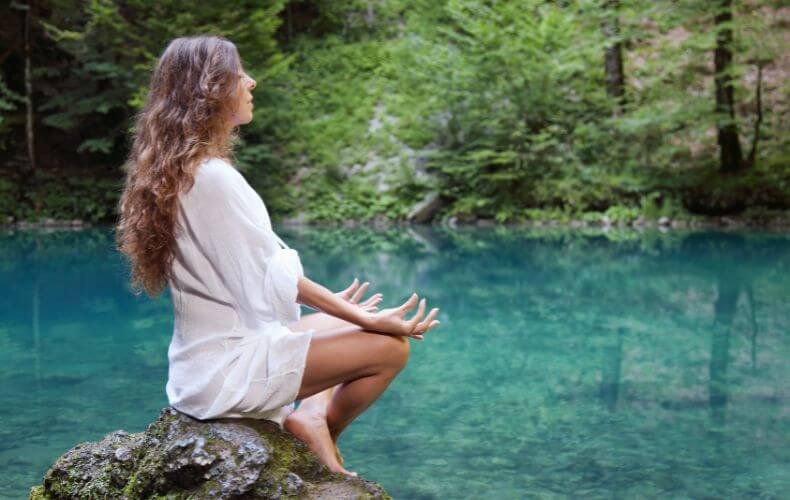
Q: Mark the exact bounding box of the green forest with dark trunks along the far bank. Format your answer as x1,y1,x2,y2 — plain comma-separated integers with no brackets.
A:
0,0,790,224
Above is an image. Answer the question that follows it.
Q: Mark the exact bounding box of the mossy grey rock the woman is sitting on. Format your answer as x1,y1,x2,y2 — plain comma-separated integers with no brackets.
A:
30,408,390,499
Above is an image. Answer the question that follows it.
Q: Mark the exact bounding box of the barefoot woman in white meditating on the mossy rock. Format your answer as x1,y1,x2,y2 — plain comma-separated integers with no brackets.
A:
117,36,439,475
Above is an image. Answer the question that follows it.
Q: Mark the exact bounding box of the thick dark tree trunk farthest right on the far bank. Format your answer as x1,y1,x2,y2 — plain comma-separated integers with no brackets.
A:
713,0,745,172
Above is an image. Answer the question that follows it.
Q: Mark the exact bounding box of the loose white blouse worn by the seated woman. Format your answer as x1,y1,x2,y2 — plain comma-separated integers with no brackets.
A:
165,158,313,426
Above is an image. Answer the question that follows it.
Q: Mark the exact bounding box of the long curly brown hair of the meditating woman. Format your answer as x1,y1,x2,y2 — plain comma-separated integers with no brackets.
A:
116,36,242,297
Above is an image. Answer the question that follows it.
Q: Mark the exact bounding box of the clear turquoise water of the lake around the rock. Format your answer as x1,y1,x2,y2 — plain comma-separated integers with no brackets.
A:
0,228,790,499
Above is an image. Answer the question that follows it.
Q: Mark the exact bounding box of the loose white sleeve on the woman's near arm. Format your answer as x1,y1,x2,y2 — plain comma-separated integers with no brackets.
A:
182,160,304,328
